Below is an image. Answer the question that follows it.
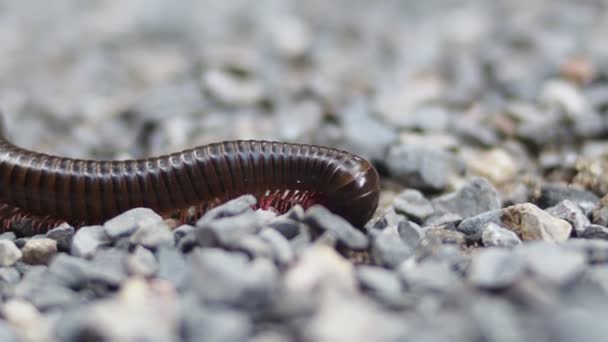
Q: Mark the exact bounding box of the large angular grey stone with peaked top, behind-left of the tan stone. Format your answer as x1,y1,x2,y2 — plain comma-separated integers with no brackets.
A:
433,177,501,218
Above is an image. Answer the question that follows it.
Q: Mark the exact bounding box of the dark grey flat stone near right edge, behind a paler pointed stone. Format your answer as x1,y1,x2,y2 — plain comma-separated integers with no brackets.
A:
536,184,600,215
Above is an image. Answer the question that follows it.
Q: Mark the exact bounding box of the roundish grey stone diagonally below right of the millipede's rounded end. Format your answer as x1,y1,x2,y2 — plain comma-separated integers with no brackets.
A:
371,226,414,268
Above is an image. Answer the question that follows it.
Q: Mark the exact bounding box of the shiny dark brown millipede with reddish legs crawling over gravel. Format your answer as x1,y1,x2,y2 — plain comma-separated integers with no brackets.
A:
0,117,379,234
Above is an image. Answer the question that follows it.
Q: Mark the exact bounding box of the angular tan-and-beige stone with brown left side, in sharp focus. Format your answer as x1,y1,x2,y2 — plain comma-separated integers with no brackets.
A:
501,203,572,242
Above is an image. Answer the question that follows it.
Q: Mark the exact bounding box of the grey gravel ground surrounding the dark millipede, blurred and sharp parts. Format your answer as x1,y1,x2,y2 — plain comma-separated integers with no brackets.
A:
0,0,608,342
